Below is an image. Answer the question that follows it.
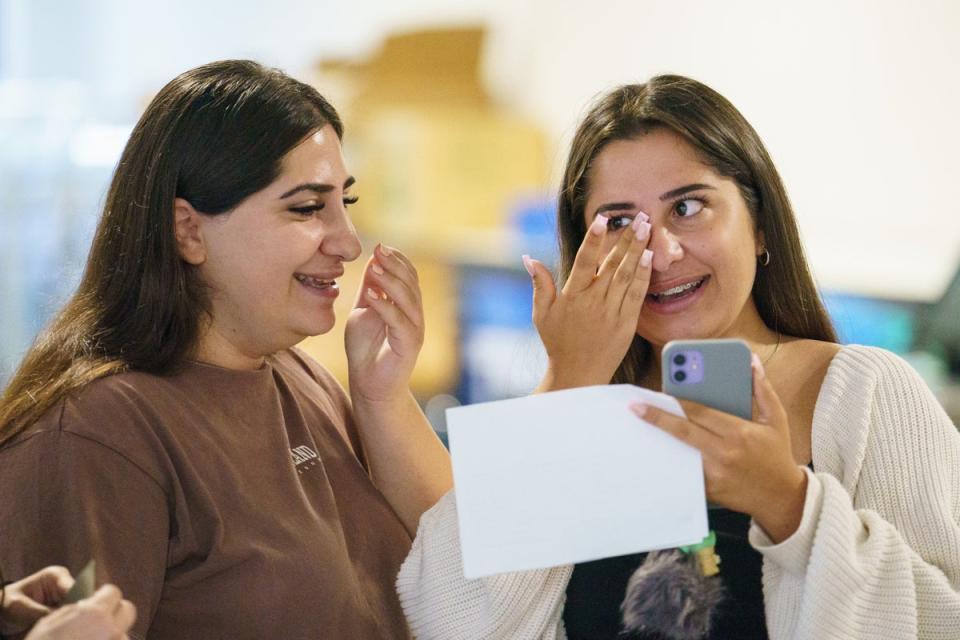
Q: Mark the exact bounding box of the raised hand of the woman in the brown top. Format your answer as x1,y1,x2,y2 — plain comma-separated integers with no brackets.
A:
345,244,424,402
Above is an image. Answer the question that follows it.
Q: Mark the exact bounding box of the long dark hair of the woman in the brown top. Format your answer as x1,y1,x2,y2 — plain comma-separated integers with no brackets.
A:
0,60,343,444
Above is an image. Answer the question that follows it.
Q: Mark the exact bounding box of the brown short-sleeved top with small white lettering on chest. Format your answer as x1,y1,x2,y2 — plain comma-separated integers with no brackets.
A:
0,350,410,640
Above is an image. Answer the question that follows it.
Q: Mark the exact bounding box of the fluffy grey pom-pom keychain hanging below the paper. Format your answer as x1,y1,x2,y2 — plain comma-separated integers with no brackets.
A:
620,531,723,640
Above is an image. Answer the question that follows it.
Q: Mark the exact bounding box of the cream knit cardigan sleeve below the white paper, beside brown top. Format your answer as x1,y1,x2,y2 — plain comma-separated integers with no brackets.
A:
397,491,573,640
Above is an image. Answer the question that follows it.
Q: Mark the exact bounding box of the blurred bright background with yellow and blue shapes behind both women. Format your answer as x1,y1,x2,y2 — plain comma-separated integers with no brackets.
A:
0,0,960,427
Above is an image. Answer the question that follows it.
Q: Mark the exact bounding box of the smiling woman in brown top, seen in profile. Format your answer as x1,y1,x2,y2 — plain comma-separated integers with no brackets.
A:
0,61,451,639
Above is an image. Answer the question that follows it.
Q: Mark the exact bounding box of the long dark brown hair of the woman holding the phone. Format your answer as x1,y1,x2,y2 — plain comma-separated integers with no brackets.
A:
557,75,837,383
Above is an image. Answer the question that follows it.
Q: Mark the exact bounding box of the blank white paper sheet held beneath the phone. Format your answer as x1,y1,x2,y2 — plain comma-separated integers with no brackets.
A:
447,385,707,578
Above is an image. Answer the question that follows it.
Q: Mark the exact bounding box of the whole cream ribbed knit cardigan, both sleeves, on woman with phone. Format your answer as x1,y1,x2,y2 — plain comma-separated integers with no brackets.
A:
397,346,960,640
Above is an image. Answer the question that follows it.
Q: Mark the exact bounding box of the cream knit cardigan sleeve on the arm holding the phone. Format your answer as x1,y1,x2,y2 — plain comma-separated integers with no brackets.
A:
750,347,960,640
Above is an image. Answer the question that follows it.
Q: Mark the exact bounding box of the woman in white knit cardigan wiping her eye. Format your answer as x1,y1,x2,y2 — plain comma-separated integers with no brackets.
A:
397,76,960,640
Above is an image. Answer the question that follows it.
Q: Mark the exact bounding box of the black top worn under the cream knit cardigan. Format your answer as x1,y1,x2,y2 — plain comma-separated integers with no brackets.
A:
563,508,767,640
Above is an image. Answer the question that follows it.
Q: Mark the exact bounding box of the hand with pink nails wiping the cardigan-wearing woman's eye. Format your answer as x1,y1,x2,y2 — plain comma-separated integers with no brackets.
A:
524,212,653,391
